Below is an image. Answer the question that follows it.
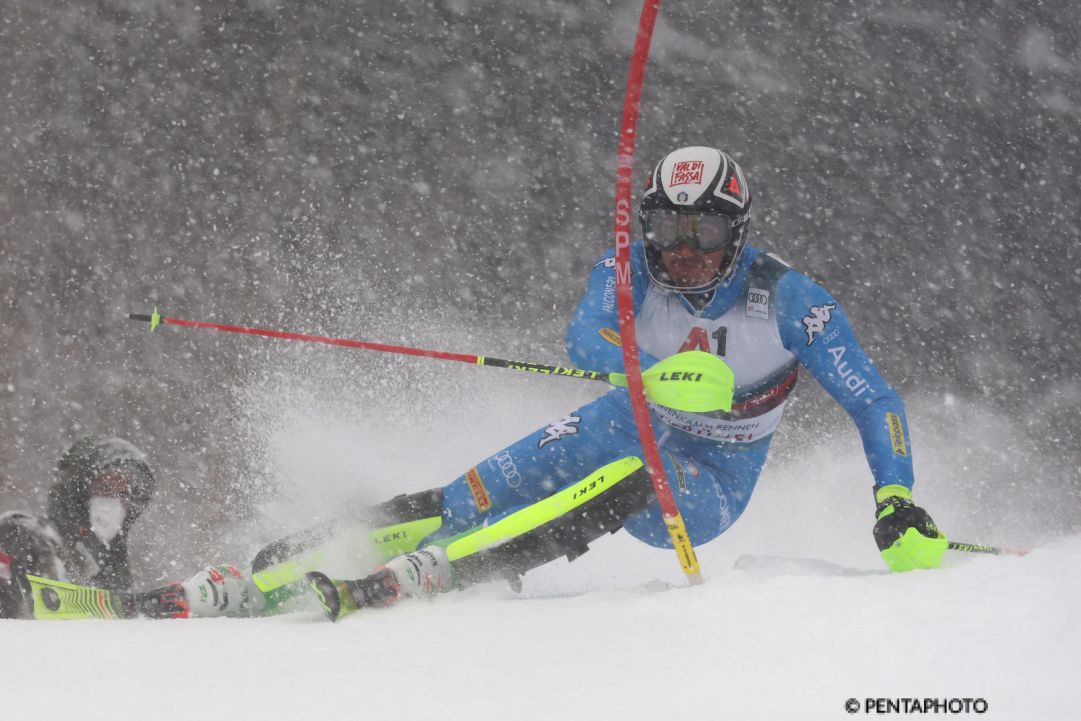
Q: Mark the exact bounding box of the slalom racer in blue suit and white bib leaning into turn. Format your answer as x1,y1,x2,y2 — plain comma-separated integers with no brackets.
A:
322,147,947,604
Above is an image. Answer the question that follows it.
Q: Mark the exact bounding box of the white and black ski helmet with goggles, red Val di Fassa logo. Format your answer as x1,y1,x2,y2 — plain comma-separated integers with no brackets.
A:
638,146,750,293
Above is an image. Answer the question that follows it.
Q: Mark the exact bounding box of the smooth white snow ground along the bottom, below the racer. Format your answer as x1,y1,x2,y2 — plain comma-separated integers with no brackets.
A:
6,534,1081,721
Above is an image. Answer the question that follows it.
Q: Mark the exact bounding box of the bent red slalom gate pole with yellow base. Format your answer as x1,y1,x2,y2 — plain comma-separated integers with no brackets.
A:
615,0,703,584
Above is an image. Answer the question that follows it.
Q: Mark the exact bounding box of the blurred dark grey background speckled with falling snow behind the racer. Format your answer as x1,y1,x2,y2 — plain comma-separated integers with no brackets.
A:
0,0,1081,579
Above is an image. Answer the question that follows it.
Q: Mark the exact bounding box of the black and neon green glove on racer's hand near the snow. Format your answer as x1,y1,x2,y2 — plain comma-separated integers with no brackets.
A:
875,485,947,571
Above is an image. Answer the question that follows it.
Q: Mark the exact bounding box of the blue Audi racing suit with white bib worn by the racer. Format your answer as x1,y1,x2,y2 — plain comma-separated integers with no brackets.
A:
440,241,912,547
